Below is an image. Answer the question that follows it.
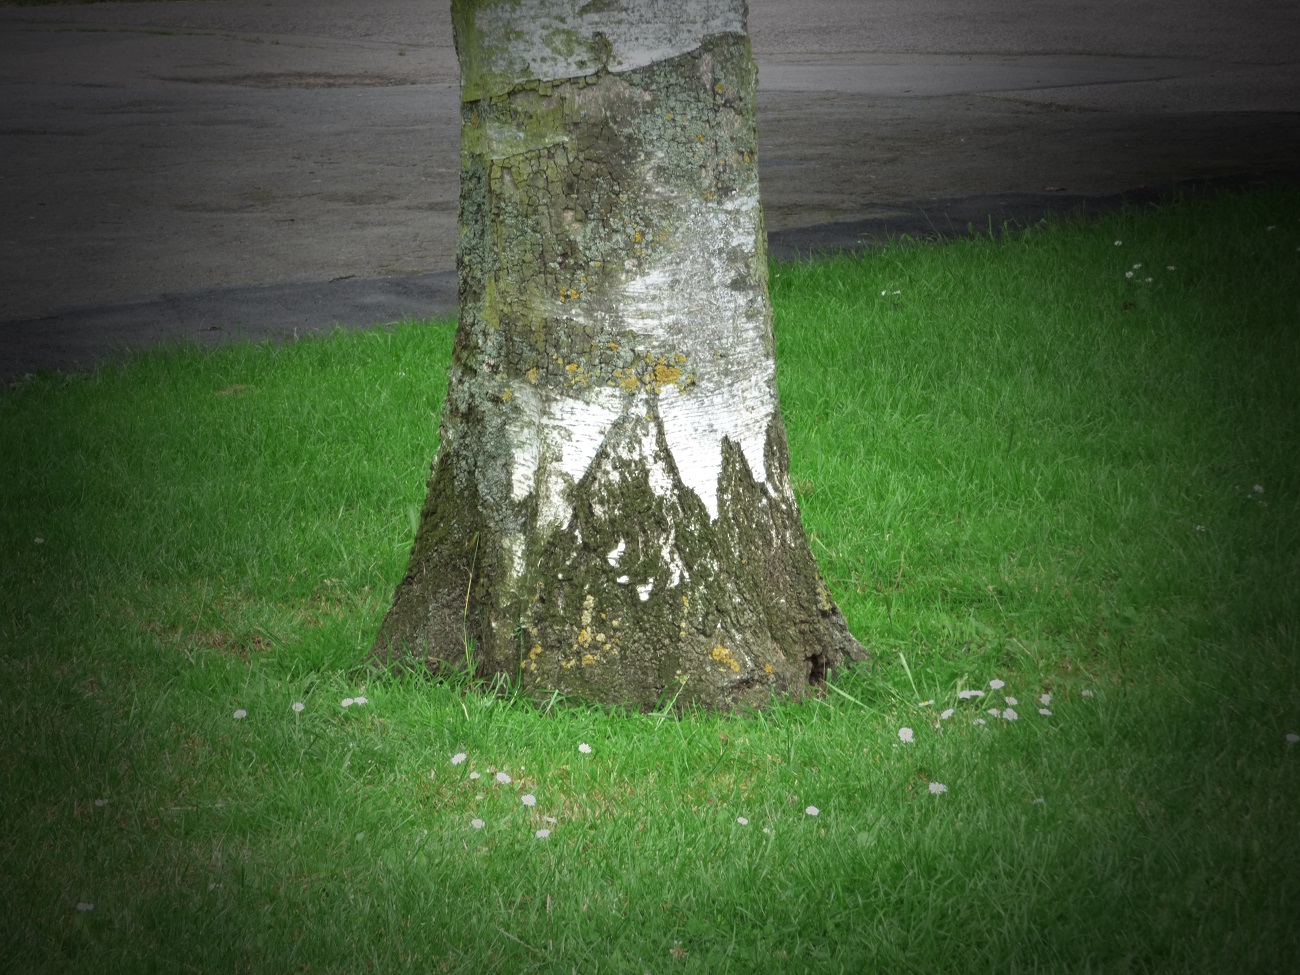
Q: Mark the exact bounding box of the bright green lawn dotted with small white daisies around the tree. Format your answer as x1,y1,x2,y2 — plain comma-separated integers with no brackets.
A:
0,191,1300,972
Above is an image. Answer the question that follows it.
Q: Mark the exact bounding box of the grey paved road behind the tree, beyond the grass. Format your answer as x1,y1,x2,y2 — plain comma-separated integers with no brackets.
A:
0,0,1300,380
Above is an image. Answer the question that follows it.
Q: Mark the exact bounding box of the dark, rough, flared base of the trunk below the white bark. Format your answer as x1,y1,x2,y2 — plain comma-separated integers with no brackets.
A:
372,413,867,710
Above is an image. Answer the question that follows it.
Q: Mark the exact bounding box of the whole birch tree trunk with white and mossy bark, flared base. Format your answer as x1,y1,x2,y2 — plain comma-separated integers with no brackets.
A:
373,0,866,709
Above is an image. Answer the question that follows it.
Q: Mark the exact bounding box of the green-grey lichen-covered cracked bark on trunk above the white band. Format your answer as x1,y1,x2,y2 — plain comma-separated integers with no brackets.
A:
462,31,766,390
